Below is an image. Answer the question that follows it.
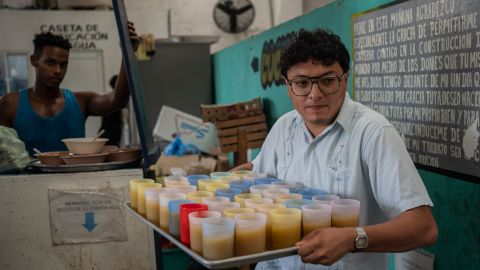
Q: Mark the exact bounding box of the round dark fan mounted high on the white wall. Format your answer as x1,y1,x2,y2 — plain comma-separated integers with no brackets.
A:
213,0,255,33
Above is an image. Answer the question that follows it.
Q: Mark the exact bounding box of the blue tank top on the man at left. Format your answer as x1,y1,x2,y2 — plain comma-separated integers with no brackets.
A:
14,89,85,156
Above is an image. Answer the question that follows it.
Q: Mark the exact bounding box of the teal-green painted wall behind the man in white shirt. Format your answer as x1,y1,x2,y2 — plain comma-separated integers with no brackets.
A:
213,0,480,269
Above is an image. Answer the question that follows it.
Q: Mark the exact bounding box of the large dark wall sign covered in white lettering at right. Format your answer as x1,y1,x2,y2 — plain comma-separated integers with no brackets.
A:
352,0,480,182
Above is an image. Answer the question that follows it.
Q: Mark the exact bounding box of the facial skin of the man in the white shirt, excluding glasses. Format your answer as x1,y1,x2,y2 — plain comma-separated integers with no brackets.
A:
286,60,348,132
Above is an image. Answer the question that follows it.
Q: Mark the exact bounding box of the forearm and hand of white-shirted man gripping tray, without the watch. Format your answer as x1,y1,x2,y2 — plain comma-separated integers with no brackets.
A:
297,205,438,265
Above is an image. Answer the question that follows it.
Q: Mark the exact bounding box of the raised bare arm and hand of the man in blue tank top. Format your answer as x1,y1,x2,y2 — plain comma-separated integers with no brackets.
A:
77,22,140,116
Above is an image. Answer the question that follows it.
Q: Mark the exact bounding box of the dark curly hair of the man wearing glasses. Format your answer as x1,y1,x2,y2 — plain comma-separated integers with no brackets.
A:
280,29,350,78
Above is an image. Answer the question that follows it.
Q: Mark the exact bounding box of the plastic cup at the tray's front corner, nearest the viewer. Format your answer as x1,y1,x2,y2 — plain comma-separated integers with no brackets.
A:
202,217,235,260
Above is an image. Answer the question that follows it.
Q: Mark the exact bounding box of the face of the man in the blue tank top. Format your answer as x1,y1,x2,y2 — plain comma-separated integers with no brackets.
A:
30,46,69,88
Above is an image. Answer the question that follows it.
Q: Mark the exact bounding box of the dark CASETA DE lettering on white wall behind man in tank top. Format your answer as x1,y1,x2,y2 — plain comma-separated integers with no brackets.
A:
40,24,108,50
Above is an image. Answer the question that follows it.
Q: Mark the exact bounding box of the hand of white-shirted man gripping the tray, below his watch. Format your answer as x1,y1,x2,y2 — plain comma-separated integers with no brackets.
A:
296,228,357,265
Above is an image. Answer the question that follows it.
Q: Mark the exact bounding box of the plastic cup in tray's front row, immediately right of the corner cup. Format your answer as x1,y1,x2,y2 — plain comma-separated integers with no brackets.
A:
235,213,267,256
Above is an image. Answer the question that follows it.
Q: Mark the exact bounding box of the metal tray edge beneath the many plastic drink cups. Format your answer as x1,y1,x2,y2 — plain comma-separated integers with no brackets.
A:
124,202,298,269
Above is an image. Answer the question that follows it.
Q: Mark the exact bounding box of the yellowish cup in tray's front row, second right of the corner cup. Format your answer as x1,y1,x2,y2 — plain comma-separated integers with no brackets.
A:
270,208,302,249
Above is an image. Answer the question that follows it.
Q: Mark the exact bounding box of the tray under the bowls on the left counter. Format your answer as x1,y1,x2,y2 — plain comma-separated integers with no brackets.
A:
27,159,141,173
